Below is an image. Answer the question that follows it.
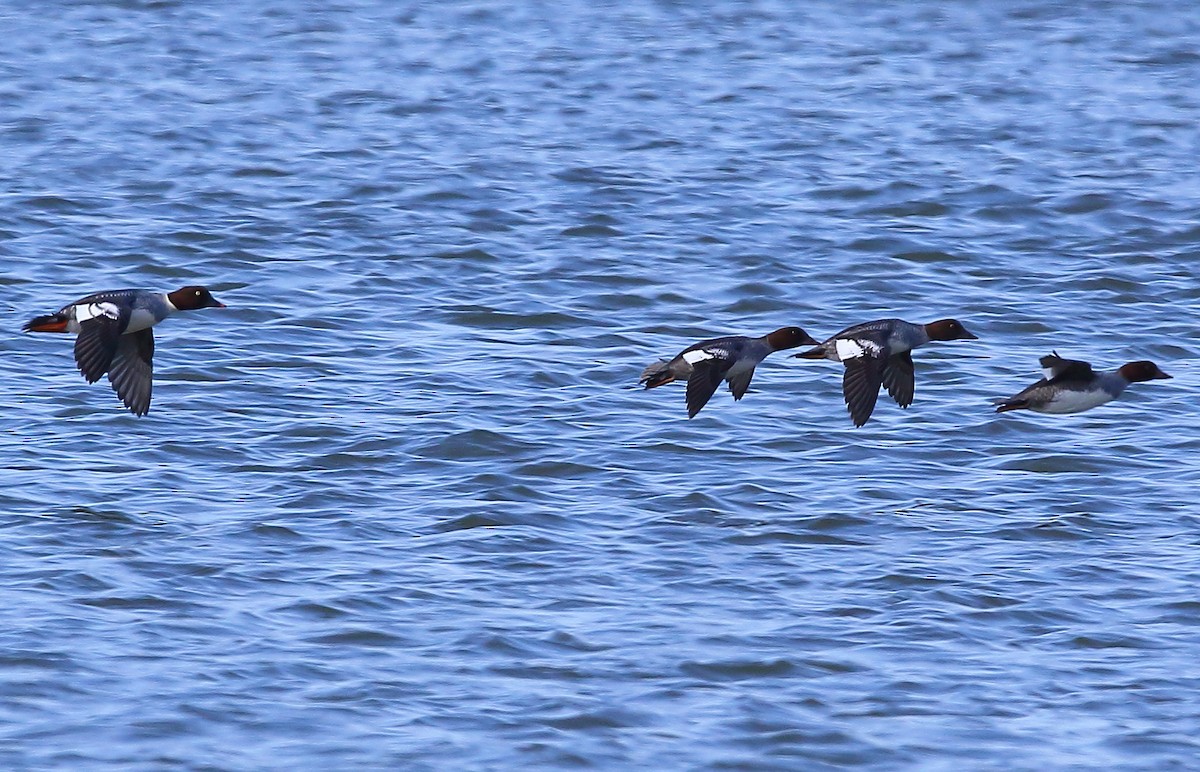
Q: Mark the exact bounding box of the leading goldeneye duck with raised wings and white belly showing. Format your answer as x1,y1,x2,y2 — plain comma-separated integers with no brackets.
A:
996,352,1171,414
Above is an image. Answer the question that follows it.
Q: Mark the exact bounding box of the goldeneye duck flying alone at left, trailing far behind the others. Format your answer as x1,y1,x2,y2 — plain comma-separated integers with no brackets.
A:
23,287,224,415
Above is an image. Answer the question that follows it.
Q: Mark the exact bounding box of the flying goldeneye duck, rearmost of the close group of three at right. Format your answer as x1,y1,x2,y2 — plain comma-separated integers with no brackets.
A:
638,327,817,418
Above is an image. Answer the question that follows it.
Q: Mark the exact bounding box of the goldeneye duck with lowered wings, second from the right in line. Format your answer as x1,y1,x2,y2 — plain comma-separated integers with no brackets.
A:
793,319,976,426
